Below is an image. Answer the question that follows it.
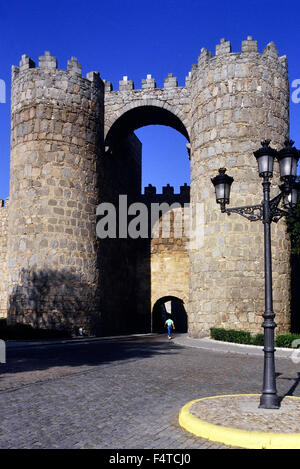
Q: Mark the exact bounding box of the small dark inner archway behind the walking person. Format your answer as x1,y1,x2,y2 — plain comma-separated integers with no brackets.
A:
152,296,188,333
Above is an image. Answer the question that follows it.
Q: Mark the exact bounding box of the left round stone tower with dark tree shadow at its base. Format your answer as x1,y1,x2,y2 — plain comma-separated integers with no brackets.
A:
8,52,104,329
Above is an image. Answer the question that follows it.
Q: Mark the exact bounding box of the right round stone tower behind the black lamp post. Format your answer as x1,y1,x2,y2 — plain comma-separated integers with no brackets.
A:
189,37,290,337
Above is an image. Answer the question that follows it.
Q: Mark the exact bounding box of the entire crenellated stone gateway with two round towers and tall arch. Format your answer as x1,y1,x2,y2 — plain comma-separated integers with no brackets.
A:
0,36,290,337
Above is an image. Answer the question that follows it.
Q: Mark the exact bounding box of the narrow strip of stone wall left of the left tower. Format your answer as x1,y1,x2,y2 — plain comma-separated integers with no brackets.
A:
0,199,8,318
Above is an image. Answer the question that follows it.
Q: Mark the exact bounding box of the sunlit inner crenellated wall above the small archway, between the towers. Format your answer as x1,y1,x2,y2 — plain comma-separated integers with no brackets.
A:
137,184,190,327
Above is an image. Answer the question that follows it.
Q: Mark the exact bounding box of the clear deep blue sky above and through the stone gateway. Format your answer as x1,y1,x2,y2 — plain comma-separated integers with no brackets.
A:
0,0,300,198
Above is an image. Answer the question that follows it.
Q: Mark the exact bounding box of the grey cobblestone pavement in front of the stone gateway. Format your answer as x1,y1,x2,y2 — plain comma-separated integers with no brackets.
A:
0,335,300,449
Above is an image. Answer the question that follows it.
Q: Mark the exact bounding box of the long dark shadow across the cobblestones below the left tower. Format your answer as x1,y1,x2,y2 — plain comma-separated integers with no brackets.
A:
0,335,181,390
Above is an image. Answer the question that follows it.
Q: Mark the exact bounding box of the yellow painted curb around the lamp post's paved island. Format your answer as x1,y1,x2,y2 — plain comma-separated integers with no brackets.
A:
179,394,300,449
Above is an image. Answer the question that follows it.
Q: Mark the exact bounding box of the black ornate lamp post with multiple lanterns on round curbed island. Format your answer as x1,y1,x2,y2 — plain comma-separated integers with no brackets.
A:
211,140,300,409
